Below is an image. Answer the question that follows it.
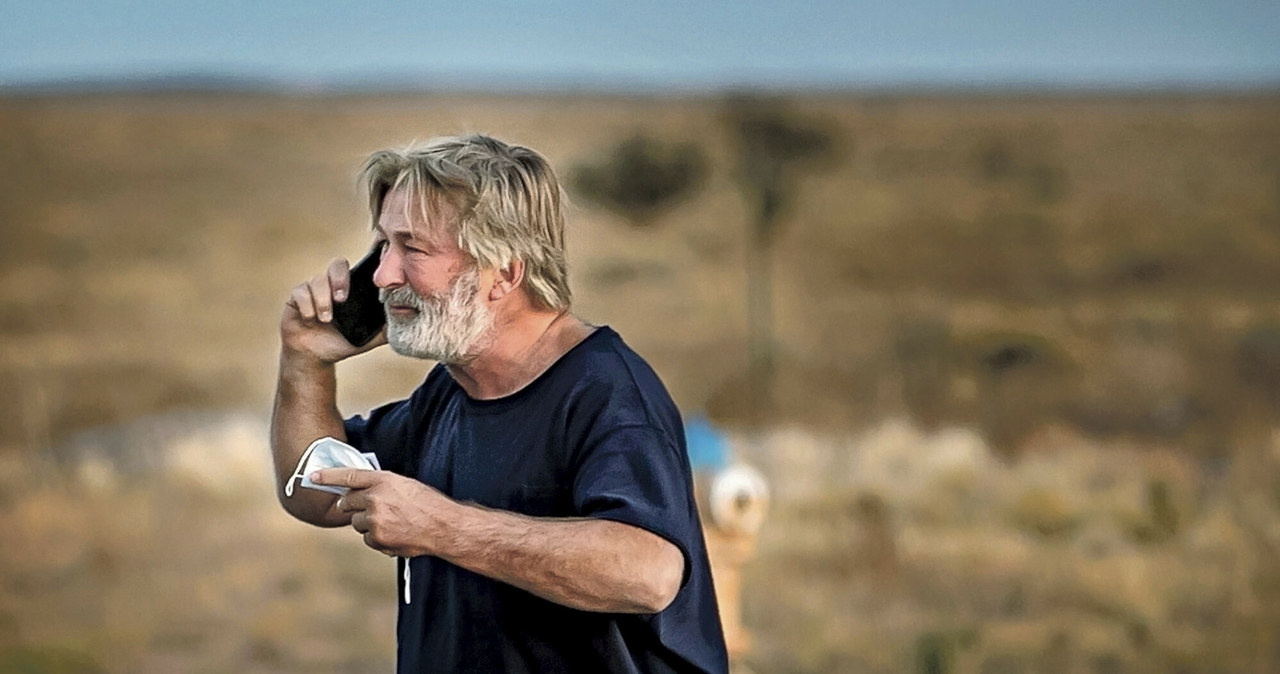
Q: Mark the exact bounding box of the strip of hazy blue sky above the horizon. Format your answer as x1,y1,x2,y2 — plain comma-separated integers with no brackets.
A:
0,0,1280,90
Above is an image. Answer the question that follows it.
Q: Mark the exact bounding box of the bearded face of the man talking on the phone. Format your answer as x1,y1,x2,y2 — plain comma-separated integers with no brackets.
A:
374,189,494,363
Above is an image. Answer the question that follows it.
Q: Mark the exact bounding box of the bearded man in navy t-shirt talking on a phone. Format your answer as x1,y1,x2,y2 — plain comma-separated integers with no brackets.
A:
271,136,727,673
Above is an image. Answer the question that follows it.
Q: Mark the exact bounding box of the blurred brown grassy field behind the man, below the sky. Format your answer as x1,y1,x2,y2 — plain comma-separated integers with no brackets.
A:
0,95,1280,674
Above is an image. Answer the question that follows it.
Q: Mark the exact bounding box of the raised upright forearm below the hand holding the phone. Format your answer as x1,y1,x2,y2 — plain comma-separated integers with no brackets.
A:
271,352,351,527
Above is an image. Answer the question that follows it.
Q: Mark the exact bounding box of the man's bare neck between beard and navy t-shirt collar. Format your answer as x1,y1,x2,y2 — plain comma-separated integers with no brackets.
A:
447,311,595,400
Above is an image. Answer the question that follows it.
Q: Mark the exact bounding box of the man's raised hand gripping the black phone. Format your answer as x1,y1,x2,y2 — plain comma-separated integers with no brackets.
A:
280,257,387,363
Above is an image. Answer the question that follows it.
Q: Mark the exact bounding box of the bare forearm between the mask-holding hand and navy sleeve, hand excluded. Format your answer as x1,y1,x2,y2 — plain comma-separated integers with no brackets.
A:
438,504,684,613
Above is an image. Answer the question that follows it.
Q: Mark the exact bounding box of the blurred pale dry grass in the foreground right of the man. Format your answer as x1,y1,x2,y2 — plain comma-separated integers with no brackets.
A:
739,422,1280,673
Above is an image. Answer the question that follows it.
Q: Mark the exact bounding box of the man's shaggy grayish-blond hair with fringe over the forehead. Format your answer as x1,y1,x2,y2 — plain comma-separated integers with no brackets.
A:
361,134,570,310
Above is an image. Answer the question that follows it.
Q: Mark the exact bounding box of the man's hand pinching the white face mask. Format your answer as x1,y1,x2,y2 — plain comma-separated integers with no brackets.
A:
311,468,457,558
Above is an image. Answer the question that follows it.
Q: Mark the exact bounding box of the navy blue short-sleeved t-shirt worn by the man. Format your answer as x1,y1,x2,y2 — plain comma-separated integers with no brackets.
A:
346,327,728,674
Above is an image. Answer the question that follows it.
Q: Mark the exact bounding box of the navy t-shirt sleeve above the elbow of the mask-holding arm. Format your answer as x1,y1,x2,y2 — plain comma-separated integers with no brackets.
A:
573,426,700,586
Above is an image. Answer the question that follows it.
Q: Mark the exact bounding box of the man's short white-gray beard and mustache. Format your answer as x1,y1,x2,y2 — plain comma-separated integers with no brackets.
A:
379,269,493,364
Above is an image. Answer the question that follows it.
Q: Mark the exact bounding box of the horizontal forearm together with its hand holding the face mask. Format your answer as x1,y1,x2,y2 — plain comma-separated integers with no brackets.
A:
316,460,685,613
